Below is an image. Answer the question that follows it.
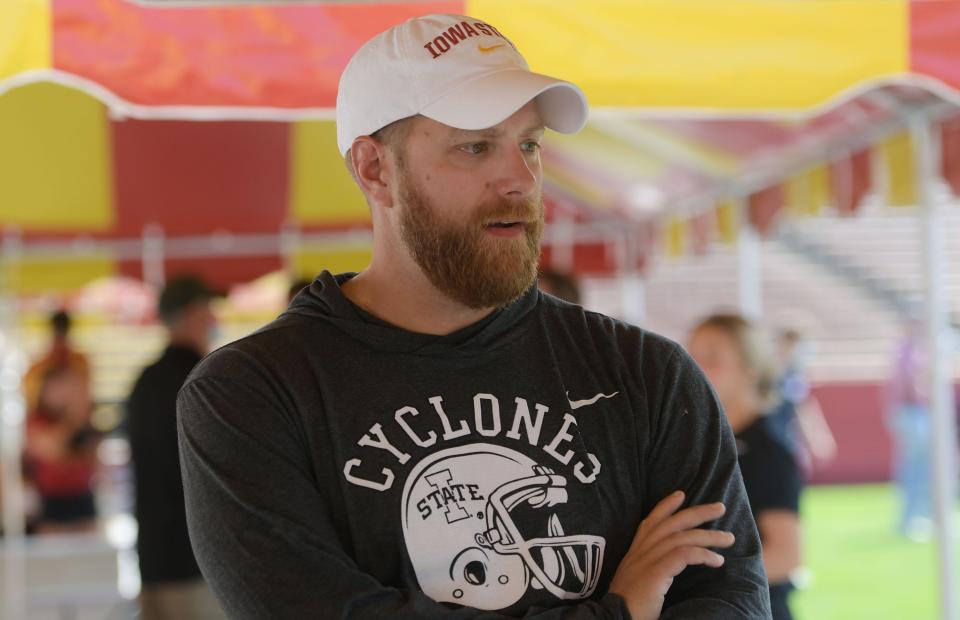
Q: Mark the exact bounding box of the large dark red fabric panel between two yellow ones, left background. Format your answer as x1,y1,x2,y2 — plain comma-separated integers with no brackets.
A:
111,120,290,236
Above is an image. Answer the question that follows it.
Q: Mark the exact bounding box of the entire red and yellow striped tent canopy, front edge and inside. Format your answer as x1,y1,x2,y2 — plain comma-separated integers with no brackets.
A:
0,0,960,286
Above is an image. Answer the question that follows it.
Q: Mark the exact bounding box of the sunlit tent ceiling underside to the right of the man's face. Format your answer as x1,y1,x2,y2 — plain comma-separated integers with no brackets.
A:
547,85,960,223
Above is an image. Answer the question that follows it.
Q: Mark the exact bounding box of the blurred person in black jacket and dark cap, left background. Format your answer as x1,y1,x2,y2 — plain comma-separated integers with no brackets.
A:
125,276,222,620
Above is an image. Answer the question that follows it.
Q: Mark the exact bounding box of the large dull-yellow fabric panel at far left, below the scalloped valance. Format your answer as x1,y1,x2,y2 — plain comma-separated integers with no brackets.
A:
0,83,114,232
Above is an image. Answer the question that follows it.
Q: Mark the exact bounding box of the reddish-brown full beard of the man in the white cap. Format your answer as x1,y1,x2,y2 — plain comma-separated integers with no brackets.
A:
399,171,544,309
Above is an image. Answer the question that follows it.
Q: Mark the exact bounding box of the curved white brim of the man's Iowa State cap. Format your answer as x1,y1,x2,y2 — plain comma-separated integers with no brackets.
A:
420,68,588,133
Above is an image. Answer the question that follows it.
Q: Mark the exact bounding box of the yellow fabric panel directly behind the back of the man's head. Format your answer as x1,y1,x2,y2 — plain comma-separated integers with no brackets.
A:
289,121,370,226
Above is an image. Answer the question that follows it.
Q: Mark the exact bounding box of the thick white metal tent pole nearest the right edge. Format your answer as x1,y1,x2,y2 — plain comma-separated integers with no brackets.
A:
910,117,957,620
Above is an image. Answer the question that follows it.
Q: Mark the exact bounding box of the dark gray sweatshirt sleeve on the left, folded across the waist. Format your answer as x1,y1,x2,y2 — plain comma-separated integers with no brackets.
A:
178,374,629,620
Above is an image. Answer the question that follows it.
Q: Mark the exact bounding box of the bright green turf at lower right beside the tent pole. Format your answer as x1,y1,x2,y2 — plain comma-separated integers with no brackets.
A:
792,485,960,620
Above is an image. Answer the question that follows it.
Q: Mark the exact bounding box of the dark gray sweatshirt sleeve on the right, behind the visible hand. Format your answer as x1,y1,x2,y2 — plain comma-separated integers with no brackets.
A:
646,346,770,620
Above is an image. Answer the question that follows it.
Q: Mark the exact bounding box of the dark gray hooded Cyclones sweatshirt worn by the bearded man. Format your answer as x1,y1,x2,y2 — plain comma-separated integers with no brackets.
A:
178,272,770,619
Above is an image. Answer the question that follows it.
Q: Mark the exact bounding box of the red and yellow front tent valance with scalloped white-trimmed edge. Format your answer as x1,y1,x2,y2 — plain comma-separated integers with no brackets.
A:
0,0,960,110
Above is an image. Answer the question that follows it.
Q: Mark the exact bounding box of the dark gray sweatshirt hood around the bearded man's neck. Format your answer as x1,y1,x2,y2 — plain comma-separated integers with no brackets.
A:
281,271,540,357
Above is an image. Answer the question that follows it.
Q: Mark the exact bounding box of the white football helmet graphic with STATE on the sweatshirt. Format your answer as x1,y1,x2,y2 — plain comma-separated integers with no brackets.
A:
402,444,606,610
